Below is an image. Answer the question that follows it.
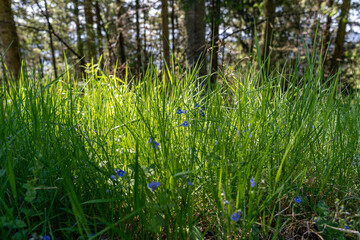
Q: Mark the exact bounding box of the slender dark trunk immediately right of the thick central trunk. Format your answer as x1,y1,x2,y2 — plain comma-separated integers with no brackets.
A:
211,0,220,84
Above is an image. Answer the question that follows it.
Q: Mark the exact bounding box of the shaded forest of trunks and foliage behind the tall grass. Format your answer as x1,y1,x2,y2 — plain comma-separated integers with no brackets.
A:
0,0,360,88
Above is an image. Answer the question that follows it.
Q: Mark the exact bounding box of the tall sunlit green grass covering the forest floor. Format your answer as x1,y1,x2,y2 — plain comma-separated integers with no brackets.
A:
0,55,360,239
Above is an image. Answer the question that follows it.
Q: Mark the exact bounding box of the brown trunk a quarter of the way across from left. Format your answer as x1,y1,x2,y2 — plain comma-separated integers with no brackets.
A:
84,0,96,62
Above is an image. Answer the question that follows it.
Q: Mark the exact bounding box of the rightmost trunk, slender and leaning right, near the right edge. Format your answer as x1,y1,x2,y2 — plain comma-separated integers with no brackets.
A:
331,0,350,74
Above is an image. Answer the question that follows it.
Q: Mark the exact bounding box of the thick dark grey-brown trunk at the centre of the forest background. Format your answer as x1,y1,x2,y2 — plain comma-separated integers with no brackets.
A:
185,0,206,75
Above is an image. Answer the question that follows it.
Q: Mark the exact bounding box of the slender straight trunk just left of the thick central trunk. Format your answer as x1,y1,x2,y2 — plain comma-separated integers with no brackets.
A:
161,0,170,66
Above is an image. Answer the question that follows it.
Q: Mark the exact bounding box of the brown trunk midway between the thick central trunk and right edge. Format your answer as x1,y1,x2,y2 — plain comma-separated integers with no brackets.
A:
261,0,276,61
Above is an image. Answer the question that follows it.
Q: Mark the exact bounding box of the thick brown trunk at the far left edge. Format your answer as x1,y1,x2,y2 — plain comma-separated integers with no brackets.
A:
0,0,21,80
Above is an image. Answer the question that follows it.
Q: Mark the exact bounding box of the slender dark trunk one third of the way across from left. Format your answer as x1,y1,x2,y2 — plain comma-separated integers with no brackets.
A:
116,0,126,64
